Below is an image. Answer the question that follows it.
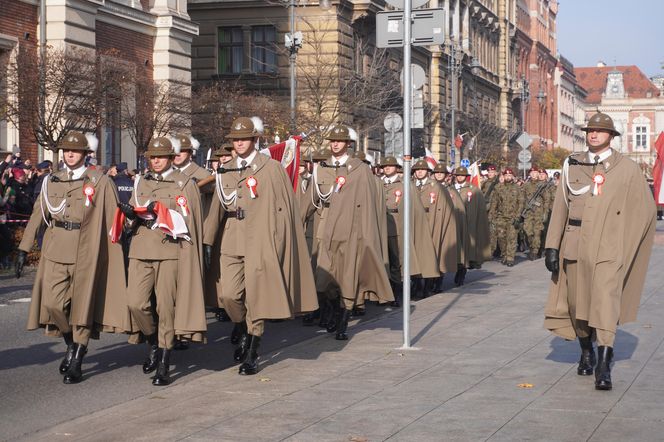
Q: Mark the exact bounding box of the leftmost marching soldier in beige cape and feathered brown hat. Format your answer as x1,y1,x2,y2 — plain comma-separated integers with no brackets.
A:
16,131,130,384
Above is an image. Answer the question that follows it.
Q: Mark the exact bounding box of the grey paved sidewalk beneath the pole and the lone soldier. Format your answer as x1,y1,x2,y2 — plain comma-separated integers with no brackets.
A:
20,237,664,441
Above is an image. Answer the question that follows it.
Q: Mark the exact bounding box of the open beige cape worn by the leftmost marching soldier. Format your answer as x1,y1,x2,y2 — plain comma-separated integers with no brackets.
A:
19,168,131,339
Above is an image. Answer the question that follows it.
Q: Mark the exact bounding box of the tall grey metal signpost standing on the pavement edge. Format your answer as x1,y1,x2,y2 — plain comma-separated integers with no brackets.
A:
402,0,413,349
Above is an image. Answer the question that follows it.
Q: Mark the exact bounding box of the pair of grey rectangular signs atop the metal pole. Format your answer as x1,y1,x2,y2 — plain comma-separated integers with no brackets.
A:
376,8,446,48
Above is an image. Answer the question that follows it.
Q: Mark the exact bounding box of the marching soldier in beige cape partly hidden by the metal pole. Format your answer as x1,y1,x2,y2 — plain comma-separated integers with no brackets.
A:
380,156,440,300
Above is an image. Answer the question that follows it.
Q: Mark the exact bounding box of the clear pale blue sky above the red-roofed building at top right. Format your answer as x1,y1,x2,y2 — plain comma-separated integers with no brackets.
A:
557,0,664,77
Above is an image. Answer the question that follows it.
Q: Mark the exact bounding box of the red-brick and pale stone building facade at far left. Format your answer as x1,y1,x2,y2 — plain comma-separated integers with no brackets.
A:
0,0,198,164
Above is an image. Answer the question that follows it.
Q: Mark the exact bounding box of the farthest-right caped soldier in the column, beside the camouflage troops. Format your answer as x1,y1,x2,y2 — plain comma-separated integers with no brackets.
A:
454,166,491,269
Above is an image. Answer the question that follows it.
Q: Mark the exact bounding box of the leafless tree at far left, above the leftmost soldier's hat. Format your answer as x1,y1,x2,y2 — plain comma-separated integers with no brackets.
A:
0,42,100,150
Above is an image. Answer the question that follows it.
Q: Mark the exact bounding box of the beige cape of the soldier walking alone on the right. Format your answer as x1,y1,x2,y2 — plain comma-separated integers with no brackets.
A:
544,151,656,339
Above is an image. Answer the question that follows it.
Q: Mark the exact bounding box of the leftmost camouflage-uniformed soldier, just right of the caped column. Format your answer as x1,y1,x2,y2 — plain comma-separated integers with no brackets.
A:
490,168,523,267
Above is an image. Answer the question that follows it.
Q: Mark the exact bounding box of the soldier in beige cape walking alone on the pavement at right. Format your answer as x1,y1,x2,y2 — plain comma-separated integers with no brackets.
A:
544,112,656,390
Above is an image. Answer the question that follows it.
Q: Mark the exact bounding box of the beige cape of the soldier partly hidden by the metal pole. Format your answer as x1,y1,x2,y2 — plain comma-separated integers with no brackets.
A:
385,178,440,278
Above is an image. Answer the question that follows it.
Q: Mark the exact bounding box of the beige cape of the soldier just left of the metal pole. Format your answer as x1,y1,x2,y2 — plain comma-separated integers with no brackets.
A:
307,158,394,305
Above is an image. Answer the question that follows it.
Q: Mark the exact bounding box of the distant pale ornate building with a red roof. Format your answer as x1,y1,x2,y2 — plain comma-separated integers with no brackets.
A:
574,63,664,165
